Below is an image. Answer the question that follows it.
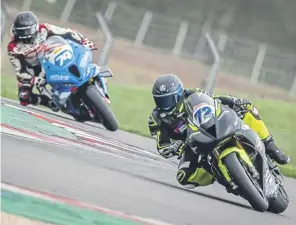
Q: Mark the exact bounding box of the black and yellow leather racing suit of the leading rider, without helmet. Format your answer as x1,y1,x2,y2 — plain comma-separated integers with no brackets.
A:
148,88,290,188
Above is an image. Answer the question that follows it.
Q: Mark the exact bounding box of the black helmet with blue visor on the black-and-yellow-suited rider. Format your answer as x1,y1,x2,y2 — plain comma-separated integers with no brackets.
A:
152,74,184,114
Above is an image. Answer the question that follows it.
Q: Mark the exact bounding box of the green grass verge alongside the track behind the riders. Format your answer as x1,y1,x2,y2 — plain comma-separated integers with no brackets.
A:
1,76,296,177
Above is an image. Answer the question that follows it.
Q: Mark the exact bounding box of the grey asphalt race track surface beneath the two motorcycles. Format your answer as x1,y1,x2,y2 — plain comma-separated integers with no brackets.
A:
1,99,296,225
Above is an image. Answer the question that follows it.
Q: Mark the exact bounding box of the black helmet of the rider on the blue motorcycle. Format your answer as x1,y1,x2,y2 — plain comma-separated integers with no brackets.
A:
12,11,39,44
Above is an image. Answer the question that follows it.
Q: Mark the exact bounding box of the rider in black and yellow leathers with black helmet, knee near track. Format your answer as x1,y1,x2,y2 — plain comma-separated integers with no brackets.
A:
148,74,290,188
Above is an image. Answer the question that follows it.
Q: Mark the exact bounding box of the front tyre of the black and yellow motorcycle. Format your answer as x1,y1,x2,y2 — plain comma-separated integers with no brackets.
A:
223,152,269,212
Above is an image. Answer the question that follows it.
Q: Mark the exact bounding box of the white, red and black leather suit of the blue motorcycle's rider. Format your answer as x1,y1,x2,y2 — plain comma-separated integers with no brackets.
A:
7,23,94,106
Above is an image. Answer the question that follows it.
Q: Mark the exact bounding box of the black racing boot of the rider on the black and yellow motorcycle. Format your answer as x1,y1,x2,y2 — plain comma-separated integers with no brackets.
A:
263,135,291,165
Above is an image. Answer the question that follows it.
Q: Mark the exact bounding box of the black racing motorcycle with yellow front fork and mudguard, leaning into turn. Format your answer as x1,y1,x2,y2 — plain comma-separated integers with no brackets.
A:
184,93,289,213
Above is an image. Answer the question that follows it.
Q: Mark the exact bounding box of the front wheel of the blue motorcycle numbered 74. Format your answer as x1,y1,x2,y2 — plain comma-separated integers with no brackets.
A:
85,86,118,131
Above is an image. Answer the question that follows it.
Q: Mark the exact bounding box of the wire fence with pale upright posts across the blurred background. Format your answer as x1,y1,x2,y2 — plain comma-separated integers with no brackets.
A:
4,0,296,95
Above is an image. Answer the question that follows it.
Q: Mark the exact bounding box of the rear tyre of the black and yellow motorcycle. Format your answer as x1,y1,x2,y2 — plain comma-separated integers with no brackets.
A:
267,185,289,213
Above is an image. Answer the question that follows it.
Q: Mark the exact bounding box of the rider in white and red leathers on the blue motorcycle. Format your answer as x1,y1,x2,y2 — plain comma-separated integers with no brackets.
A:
7,11,109,108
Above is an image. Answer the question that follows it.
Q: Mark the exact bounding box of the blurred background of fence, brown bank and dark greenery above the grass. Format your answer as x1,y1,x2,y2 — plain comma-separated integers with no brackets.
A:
1,0,296,99
